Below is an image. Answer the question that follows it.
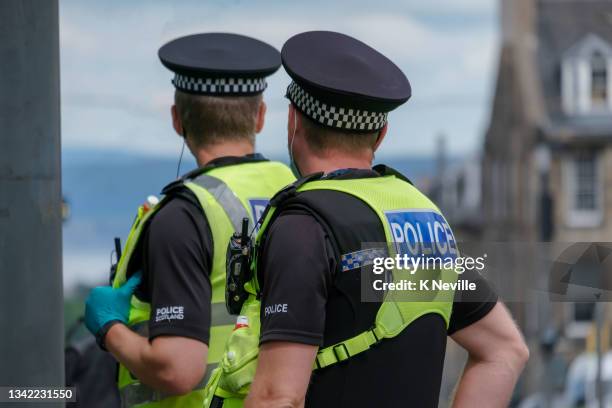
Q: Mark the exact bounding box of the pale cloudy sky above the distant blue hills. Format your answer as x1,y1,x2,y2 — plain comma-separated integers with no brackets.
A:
60,0,499,157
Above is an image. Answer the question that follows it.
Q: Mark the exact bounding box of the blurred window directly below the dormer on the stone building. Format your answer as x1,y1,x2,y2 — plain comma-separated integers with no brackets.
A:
565,151,603,228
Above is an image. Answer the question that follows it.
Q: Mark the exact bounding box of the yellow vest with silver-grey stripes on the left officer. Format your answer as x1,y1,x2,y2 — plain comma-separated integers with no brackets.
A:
113,161,295,408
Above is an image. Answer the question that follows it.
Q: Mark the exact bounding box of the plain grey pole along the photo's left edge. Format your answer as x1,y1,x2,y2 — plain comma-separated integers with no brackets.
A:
0,0,64,407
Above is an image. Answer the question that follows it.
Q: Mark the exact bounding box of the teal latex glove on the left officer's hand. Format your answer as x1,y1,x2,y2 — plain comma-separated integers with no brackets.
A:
85,272,142,346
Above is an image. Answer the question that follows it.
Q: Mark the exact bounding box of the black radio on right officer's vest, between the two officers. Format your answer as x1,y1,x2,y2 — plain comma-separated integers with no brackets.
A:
225,217,252,315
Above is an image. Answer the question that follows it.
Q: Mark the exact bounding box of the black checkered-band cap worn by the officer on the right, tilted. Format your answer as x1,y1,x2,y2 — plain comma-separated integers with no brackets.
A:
281,31,412,132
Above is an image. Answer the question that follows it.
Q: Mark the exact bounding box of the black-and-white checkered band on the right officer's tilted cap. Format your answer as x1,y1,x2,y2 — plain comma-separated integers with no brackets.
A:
287,82,387,131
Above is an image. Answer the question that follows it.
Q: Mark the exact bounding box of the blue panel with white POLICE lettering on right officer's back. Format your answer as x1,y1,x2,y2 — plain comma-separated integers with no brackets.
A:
385,209,458,259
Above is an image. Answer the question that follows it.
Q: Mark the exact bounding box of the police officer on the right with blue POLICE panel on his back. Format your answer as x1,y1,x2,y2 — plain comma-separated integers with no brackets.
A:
246,31,528,408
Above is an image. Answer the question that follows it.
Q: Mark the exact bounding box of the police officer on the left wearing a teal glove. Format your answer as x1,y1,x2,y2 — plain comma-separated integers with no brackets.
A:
86,33,295,407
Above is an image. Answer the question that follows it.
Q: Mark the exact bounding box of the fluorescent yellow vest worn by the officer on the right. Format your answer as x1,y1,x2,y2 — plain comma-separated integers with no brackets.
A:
204,171,458,408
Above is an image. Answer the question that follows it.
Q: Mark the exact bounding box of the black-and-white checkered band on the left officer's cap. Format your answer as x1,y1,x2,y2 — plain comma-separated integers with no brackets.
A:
172,74,268,95
